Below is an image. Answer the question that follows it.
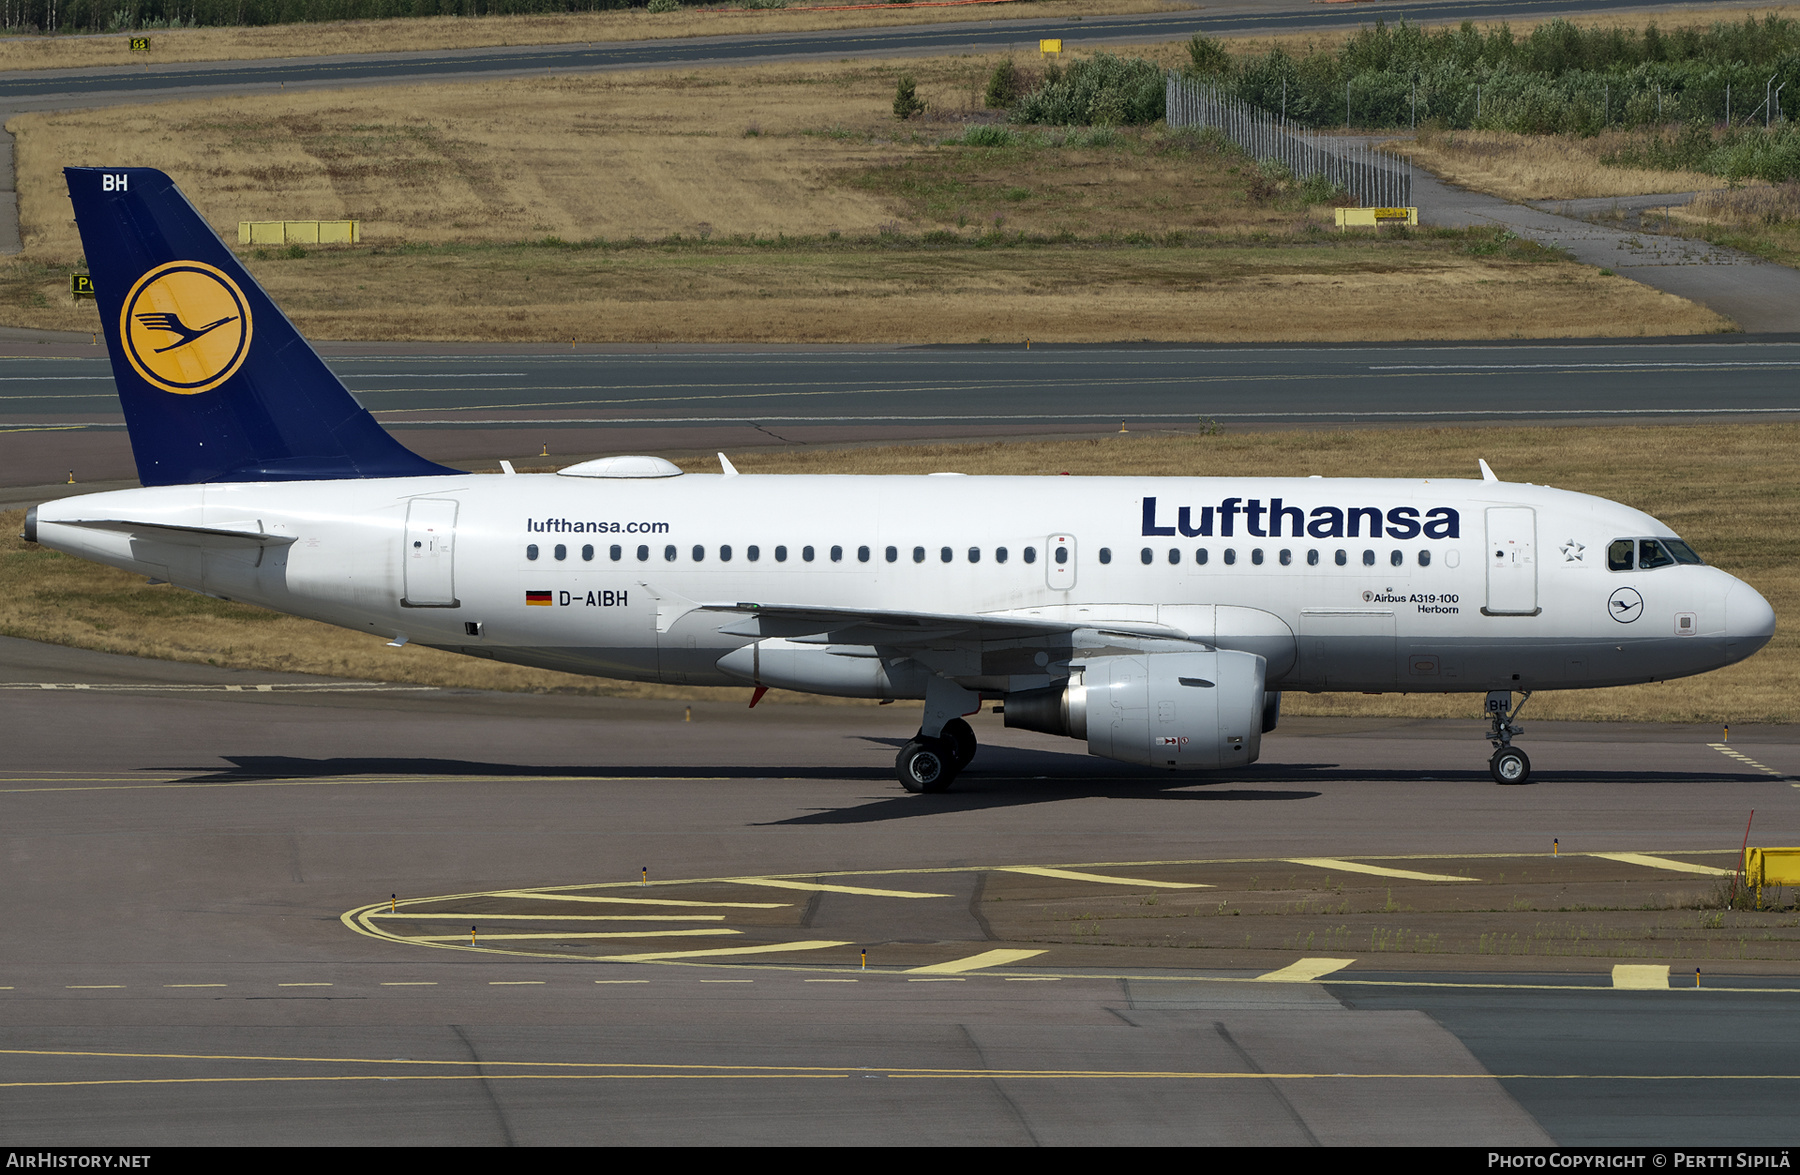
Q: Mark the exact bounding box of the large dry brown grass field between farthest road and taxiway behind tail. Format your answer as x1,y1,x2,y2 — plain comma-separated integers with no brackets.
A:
0,56,1730,342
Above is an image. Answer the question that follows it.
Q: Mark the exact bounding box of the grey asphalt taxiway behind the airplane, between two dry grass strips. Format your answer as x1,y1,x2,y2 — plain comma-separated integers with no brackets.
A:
0,333,1800,502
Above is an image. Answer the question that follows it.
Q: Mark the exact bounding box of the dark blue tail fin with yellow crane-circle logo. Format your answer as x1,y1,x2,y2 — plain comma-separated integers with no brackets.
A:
63,167,455,486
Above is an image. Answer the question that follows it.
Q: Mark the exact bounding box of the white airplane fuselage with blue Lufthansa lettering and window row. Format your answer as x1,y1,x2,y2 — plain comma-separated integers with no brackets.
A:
36,473,1773,696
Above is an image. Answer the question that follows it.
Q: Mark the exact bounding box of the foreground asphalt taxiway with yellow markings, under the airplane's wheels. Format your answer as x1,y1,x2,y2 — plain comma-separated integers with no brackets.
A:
0,641,1800,1146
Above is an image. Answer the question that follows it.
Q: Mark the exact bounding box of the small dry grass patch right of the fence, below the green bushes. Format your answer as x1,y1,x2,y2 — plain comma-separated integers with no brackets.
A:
1390,131,1721,200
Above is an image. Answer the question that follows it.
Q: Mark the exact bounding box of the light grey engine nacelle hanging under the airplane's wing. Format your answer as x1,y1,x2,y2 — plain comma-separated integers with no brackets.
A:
1004,650,1280,770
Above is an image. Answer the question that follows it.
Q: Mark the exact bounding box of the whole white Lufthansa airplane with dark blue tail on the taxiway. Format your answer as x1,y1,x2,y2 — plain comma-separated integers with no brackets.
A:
25,167,1775,792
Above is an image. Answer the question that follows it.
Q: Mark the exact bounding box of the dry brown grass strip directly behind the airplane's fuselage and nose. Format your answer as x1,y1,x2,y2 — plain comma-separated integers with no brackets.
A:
0,425,1800,723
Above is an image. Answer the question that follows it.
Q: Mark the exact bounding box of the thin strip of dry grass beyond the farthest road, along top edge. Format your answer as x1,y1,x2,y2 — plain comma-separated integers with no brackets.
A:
0,0,1193,70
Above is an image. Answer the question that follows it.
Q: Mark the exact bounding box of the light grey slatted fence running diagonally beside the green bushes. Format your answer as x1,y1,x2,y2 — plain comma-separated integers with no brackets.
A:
1163,74,1413,209
